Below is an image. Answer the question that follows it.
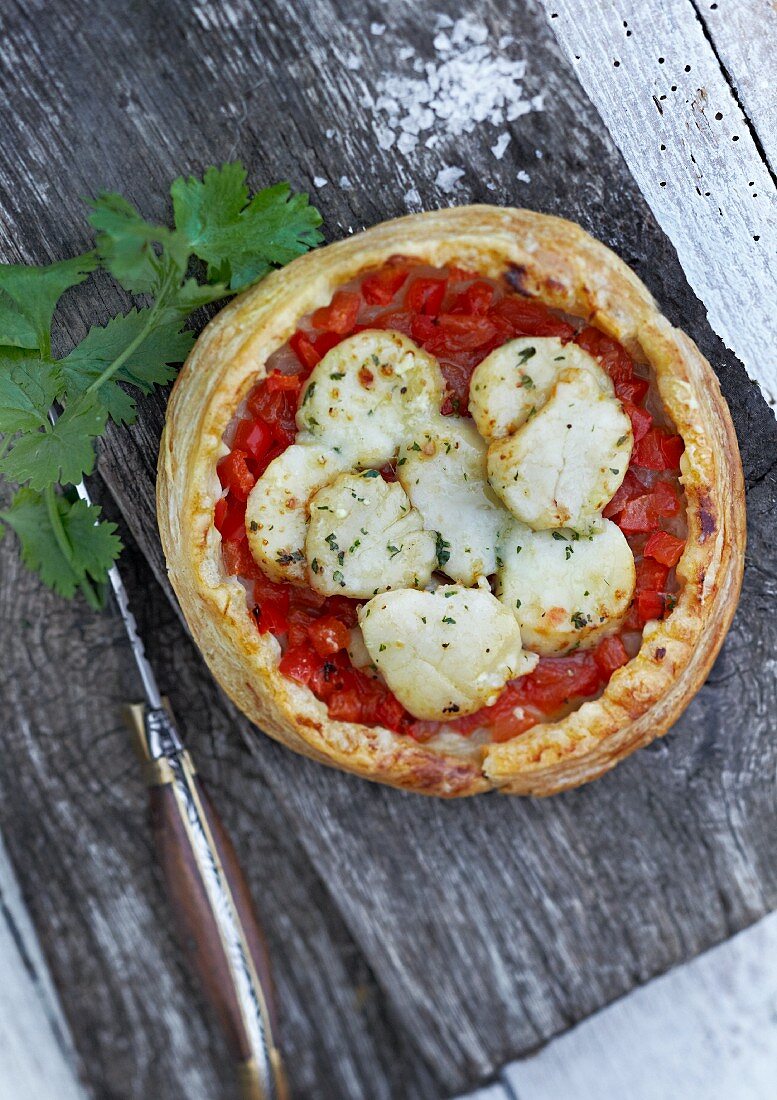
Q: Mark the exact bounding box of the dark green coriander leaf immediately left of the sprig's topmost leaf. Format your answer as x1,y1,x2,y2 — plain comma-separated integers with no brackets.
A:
89,191,189,295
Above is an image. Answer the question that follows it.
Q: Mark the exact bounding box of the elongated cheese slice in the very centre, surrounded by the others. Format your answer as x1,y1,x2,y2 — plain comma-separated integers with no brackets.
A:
396,417,510,584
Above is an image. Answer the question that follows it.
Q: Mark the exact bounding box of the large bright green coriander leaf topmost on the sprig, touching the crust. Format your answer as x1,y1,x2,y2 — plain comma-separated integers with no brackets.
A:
171,162,321,290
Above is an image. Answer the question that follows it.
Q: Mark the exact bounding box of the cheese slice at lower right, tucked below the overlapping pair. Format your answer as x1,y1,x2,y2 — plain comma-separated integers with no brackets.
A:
496,519,635,656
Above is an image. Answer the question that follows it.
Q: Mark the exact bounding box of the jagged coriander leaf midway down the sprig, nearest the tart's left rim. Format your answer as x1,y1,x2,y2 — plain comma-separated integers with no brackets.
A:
59,309,194,424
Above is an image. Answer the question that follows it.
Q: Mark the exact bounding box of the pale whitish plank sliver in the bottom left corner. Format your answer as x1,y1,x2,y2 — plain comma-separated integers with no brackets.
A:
0,838,86,1100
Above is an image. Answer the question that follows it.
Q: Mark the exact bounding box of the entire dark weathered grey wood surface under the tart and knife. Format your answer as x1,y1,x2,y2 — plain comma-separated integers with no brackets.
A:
0,0,777,1100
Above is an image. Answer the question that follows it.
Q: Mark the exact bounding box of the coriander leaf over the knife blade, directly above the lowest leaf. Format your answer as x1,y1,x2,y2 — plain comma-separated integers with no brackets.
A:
0,394,107,490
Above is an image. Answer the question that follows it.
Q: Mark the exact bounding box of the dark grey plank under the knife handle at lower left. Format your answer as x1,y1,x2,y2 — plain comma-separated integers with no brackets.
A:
0,495,439,1100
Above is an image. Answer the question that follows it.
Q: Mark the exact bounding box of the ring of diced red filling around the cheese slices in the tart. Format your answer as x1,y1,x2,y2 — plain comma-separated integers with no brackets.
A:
214,256,685,741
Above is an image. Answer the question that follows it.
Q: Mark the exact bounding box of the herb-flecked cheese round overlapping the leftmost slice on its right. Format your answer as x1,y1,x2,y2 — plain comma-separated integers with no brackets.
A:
305,470,437,598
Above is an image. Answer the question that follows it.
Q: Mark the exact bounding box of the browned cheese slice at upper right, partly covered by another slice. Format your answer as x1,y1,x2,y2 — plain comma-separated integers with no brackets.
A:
469,337,613,440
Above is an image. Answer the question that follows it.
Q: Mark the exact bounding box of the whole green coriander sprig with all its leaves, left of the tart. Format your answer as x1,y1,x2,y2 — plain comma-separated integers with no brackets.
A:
0,163,321,607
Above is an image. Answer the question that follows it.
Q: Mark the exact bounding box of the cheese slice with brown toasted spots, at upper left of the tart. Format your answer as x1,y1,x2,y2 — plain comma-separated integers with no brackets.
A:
297,329,445,466
